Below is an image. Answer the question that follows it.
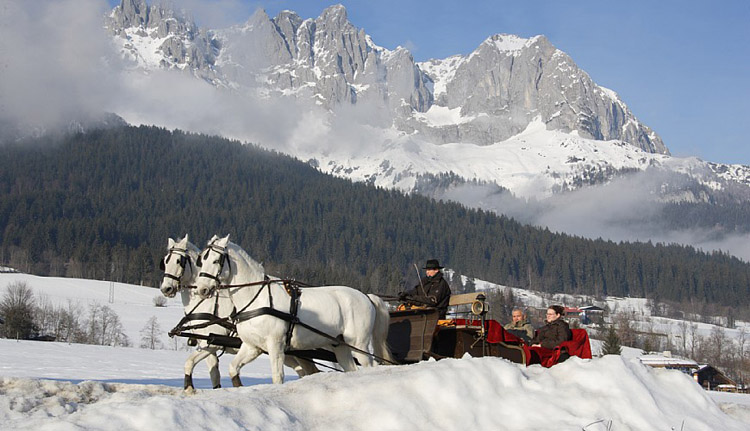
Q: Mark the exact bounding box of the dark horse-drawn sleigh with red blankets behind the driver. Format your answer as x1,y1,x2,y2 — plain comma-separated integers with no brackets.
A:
388,293,591,367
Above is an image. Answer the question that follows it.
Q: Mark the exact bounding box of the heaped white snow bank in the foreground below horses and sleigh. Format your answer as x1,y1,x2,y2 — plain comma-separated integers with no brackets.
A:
0,349,748,431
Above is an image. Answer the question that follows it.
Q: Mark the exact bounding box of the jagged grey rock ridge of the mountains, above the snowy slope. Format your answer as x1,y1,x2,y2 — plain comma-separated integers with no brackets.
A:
104,0,668,163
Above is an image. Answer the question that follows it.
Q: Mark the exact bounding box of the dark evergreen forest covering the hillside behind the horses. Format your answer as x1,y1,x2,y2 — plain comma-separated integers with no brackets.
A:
0,126,750,306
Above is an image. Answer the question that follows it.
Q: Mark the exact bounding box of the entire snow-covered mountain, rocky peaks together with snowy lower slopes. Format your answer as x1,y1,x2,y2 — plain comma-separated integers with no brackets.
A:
107,0,750,201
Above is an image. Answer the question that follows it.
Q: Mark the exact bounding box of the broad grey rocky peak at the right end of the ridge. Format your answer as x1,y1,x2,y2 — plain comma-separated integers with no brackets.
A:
418,34,669,154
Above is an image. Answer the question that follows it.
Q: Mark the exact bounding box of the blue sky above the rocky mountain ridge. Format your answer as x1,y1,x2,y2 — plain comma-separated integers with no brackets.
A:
110,0,750,165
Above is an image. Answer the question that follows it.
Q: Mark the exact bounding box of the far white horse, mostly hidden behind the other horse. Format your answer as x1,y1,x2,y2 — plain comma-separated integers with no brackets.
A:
160,235,318,393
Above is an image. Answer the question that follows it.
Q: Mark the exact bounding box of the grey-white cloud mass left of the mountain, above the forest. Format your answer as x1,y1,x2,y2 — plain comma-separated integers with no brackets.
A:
0,0,118,130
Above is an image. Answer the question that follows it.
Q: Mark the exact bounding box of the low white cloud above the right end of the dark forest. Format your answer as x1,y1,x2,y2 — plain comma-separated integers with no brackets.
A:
442,171,750,262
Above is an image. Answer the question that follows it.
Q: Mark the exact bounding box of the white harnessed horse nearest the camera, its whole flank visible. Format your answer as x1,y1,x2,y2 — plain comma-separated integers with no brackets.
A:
196,235,393,386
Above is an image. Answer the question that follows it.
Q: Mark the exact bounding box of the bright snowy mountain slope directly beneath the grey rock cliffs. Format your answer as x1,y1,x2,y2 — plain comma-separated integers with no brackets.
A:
296,117,716,199
